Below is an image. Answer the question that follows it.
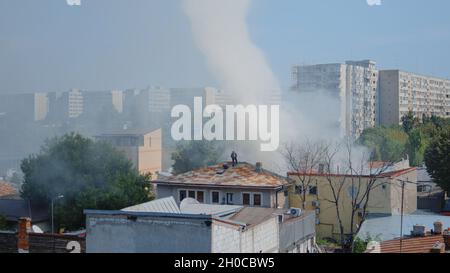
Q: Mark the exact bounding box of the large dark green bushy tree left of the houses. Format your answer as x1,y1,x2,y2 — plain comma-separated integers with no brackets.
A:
21,133,151,230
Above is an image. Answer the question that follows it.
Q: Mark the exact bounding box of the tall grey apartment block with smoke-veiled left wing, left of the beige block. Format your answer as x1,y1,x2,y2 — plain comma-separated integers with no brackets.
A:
292,60,378,137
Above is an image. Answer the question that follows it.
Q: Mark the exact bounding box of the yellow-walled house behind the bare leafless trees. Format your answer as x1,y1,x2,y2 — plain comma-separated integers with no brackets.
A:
288,168,417,238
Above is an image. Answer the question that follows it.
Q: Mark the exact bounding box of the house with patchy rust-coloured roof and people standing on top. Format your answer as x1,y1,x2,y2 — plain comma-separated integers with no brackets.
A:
153,162,288,208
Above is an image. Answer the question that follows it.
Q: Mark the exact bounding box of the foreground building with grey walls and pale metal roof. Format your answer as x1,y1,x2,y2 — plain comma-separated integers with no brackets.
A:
85,197,317,253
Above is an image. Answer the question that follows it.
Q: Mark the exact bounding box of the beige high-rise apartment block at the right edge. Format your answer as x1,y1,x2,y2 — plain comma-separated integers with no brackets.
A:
380,70,450,126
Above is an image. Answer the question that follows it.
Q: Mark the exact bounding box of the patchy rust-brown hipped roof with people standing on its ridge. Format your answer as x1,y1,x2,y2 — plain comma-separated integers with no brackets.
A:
153,162,287,189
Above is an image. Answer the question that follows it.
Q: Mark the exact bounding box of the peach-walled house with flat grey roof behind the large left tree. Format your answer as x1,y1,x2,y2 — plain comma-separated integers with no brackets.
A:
96,129,162,174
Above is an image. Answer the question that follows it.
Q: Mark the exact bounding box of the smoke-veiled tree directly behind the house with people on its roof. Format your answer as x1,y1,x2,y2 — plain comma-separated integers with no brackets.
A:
172,141,223,174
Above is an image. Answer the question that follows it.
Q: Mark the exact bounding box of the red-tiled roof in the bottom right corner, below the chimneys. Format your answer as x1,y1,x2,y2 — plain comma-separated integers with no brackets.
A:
381,235,444,253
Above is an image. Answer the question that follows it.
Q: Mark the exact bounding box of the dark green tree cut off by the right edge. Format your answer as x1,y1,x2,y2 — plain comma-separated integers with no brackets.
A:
425,126,450,191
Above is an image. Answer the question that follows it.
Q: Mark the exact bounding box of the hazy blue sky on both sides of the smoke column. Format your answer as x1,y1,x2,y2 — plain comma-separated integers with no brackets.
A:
0,0,450,93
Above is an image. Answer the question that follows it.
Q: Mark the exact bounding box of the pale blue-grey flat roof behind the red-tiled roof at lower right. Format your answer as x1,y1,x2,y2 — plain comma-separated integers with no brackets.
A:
357,214,450,241
